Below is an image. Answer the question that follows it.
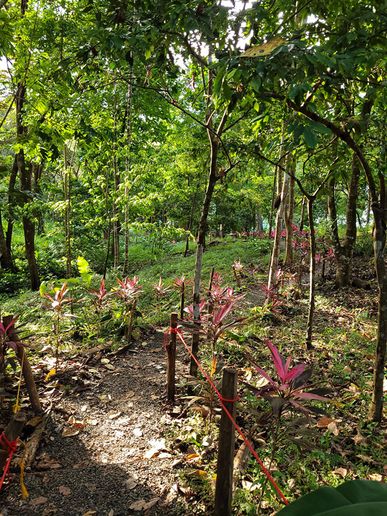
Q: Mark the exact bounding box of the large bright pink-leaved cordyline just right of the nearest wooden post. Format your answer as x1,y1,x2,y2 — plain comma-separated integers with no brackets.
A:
249,340,329,416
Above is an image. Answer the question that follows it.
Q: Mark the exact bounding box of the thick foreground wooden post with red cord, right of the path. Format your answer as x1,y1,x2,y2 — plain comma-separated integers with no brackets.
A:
215,368,237,516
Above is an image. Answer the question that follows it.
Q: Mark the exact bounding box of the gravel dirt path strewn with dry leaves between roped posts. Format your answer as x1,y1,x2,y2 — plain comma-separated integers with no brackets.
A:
0,338,187,516
